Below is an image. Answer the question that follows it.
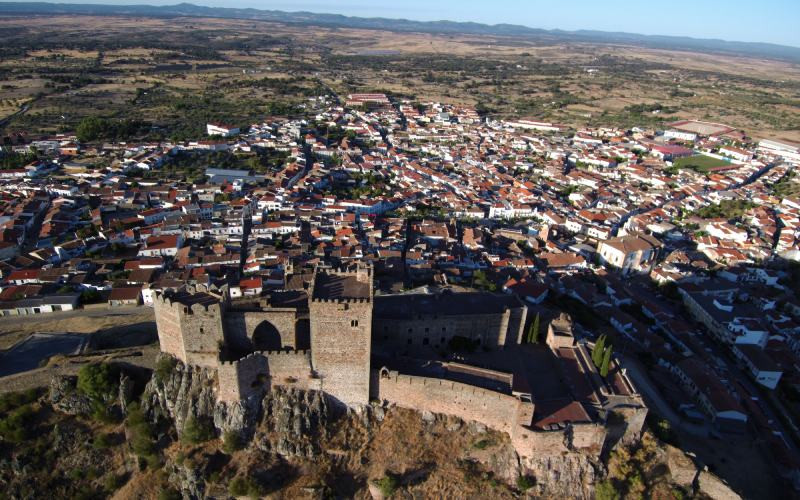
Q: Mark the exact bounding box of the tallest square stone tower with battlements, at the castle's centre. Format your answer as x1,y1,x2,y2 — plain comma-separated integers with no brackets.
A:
309,265,373,406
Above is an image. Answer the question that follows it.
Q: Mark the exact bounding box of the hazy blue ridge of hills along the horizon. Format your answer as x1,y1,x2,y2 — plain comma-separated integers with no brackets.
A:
0,2,800,62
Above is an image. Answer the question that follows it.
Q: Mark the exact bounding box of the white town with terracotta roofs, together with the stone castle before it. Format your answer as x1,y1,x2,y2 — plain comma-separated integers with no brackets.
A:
0,93,800,496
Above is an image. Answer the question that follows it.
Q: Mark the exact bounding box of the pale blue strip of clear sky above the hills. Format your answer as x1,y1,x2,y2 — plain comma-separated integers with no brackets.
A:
48,0,800,47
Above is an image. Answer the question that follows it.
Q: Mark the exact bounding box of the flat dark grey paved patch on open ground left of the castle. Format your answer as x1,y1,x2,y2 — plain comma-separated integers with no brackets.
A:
0,333,88,377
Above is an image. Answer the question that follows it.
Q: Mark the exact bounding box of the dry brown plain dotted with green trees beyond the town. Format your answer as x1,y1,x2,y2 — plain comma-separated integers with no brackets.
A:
0,15,800,141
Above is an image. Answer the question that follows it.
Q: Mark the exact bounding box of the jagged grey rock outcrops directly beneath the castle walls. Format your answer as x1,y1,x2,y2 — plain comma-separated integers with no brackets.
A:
142,363,601,499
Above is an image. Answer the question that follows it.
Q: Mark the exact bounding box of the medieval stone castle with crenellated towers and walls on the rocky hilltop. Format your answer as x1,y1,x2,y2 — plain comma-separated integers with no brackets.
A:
154,266,646,456
